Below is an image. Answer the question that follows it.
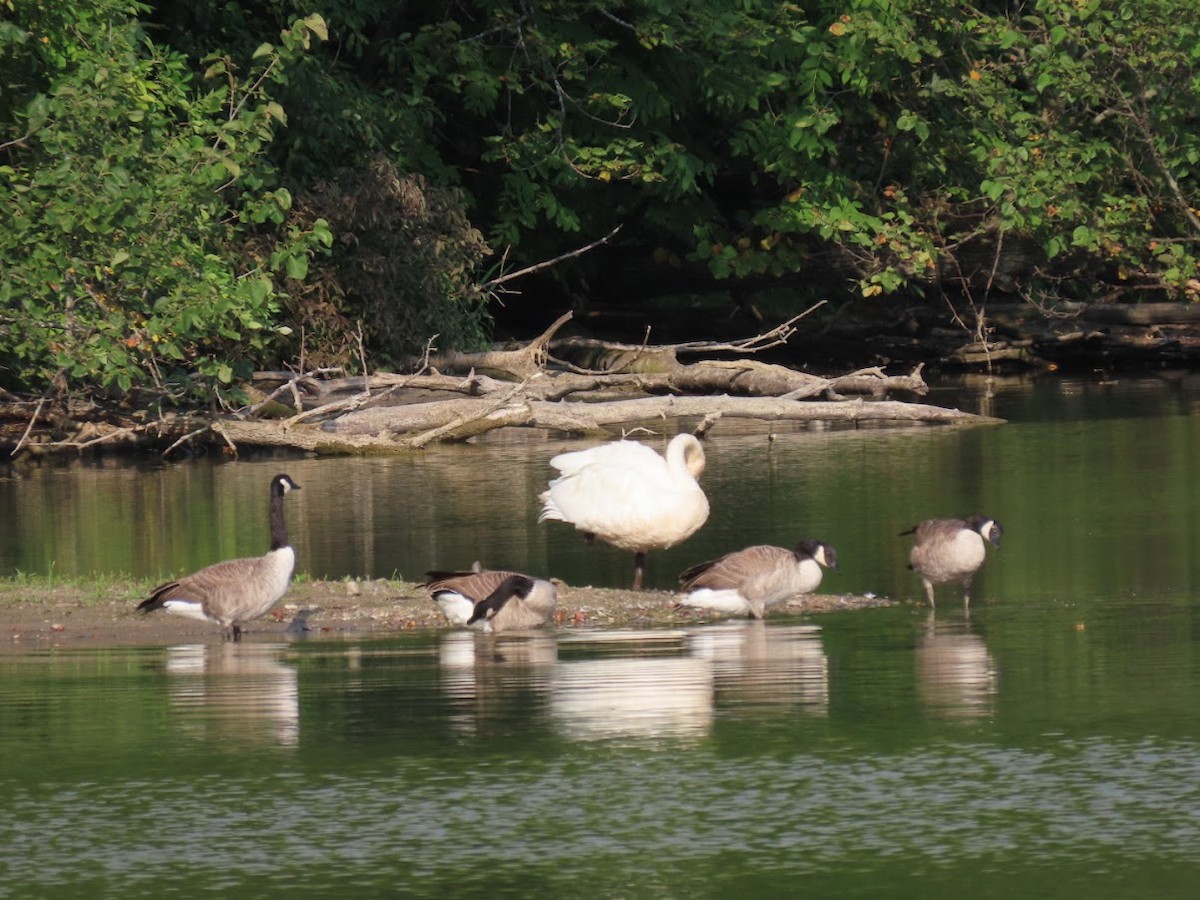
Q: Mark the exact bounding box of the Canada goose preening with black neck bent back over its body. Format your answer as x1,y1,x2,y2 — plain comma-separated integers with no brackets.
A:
425,563,558,631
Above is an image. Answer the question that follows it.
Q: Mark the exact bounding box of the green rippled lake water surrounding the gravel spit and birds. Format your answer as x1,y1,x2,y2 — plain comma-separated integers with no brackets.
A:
0,377,1200,900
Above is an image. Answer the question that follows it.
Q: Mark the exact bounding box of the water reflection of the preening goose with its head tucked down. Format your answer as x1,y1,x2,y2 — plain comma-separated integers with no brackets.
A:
438,631,558,734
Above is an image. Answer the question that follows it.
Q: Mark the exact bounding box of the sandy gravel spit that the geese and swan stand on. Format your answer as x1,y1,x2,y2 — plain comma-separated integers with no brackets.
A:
0,581,894,653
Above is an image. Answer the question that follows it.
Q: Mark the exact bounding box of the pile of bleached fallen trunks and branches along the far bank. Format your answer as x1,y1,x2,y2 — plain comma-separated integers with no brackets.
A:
0,314,996,454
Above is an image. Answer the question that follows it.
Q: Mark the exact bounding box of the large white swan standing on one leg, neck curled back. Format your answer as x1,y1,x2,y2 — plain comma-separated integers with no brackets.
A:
538,434,708,590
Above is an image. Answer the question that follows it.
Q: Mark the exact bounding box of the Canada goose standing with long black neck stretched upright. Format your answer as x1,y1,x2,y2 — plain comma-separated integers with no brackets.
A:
138,475,300,641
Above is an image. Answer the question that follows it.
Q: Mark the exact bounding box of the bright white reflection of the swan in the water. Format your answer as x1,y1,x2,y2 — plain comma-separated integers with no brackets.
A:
550,631,713,740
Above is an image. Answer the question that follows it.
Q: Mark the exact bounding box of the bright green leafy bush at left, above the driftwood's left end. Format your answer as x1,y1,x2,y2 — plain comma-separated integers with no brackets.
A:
0,4,329,392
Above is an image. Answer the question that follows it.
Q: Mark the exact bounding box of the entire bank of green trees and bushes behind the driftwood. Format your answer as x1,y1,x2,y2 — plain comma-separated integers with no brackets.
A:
0,0,1200,405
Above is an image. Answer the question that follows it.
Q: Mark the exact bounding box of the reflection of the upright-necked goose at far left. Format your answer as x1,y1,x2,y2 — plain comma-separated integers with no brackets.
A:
166,643,300,746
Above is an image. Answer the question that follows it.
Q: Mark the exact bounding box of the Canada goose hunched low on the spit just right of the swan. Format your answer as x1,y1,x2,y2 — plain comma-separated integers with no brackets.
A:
679,540,838,619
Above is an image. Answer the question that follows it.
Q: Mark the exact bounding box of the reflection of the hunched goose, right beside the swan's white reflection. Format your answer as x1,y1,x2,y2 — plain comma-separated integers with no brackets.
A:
689,619,829,716
